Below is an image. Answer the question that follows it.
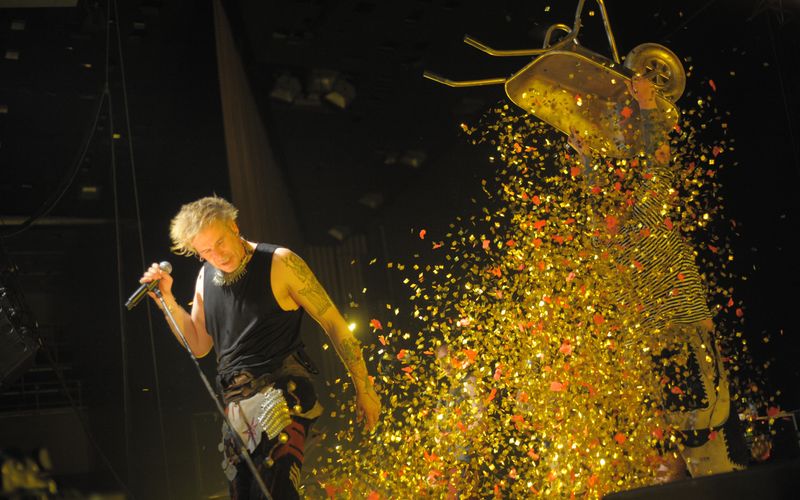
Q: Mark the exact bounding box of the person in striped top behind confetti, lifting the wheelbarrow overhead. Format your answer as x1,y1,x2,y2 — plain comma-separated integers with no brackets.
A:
569,76,749,481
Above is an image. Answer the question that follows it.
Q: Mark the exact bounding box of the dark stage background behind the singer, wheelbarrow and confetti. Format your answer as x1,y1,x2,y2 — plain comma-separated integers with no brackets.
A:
0,0,800,499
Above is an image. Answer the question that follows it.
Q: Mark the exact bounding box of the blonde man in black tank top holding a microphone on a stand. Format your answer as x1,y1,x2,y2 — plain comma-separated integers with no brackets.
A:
140,196,381,499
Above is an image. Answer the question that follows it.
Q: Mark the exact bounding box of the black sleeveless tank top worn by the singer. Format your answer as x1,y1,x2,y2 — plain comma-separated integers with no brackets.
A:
203,243,303,383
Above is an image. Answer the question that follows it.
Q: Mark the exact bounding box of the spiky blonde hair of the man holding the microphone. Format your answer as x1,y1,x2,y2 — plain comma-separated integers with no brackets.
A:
169,195,239,255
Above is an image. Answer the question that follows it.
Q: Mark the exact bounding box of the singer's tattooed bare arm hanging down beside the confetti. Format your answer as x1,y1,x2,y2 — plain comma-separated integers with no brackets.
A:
272,248,381,430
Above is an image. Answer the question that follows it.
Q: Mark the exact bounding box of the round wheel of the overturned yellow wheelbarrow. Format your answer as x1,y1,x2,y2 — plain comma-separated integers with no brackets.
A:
625,43,686,102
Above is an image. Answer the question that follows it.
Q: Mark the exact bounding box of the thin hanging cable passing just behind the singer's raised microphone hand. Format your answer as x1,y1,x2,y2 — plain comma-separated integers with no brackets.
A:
113,0,172,498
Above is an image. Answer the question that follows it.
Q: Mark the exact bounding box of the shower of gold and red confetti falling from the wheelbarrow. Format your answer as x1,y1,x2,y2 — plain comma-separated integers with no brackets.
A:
306,81,769,499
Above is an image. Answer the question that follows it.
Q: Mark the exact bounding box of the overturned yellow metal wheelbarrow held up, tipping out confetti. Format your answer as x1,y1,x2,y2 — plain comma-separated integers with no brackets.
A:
423,0,686,158
